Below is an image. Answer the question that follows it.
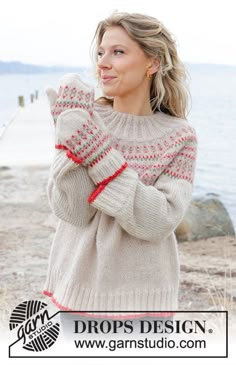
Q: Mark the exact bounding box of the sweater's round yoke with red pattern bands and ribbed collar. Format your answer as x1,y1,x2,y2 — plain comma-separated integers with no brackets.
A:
95,104,196,185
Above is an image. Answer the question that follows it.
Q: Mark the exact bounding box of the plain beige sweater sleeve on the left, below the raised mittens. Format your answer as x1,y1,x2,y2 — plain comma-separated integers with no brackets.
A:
47,150,97,226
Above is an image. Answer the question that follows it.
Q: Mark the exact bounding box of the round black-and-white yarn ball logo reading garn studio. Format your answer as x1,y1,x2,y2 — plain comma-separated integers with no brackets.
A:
9,300,60,352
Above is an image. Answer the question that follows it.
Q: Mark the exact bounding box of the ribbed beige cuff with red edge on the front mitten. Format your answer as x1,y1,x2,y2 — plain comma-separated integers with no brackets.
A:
88,148,128,185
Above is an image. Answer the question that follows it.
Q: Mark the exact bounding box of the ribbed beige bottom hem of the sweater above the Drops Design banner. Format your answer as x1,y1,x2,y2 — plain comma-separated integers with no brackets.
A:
43,270,178,312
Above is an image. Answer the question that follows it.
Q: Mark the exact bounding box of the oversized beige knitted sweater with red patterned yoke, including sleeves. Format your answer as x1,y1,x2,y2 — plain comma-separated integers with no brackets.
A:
43,104,197,312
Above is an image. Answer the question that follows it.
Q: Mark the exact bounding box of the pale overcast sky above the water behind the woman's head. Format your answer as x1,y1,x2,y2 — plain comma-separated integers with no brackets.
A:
0,0,236,67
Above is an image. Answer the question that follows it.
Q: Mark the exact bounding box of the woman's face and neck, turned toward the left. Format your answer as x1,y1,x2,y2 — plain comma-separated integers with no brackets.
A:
97,26,151,98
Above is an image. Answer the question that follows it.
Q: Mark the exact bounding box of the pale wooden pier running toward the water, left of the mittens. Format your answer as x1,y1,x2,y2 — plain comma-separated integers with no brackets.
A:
0,98,54,166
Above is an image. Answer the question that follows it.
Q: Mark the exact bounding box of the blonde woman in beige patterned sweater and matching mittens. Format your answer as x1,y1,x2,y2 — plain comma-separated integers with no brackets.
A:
44,13,197,336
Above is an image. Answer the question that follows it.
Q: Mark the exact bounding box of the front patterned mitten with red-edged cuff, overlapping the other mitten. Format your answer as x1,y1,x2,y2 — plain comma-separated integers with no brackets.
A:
56,108,127,185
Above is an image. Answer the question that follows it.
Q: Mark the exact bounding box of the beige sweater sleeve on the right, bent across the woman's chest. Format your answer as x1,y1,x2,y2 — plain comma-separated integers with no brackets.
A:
89,128,197,241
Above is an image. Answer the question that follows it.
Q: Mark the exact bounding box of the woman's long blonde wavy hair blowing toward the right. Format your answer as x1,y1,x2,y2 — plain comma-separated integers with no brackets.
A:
93,12,189,119
